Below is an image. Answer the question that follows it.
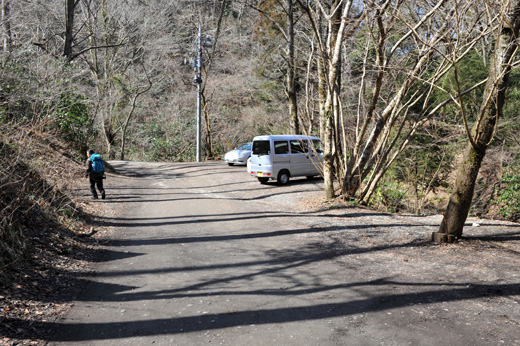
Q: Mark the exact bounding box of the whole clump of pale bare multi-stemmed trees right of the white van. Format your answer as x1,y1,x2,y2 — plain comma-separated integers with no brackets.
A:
300,0,500,207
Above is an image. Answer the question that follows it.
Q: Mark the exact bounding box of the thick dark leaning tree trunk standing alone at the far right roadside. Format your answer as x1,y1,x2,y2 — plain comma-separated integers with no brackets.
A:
440,0,520,238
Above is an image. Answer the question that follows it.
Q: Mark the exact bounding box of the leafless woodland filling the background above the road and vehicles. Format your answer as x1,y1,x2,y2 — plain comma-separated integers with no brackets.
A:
0,0,520,237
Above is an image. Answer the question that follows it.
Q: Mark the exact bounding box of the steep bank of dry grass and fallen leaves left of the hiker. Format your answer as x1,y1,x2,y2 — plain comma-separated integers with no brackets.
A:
0,125,100,345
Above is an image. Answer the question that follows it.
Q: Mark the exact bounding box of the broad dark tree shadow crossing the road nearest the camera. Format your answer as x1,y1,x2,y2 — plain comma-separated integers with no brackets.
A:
3,279,520,342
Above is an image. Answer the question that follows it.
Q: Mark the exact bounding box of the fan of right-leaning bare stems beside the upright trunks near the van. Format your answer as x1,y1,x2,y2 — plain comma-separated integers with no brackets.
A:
342,0,456,202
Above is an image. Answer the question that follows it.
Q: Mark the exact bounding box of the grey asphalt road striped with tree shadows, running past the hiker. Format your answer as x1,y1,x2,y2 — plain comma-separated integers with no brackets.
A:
50,161,518,346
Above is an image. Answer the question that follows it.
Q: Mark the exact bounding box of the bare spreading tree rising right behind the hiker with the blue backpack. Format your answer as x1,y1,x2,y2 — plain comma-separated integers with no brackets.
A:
81,0,151,159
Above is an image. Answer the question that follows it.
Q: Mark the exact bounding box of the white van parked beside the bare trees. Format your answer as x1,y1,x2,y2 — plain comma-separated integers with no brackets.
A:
248,135,323,185
